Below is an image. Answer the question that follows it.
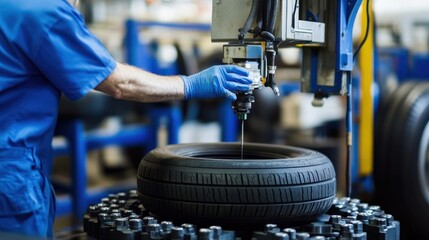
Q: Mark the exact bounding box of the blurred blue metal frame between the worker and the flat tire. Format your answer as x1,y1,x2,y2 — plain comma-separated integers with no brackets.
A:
53,105,182,221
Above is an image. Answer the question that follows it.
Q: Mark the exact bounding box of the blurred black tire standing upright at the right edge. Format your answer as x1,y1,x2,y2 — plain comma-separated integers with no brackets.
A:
374,82,429,239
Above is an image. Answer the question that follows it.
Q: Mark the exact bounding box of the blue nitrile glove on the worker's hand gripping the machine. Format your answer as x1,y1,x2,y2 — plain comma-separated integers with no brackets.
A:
181,65,252,100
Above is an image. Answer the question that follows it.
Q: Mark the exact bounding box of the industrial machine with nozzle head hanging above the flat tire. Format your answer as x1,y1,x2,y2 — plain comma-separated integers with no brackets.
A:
211,0,362,195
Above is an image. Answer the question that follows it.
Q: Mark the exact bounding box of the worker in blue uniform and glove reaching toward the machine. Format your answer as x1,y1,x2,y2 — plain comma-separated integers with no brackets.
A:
0,0,251,237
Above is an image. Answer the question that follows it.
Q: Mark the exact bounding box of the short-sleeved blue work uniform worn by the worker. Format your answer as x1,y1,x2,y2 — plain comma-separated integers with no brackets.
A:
0,0,116,236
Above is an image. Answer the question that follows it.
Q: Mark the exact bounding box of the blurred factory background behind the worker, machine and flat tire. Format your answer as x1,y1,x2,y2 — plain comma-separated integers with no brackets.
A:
52,0,429,238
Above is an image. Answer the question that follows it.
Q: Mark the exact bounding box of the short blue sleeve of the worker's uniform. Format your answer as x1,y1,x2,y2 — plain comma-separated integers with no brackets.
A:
21,0,116,100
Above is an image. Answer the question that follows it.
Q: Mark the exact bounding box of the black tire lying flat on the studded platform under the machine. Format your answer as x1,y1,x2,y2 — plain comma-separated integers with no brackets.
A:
137,143,336,227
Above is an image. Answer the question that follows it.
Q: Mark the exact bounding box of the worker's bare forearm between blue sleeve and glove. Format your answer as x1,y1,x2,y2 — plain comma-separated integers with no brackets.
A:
95,63,185,102
